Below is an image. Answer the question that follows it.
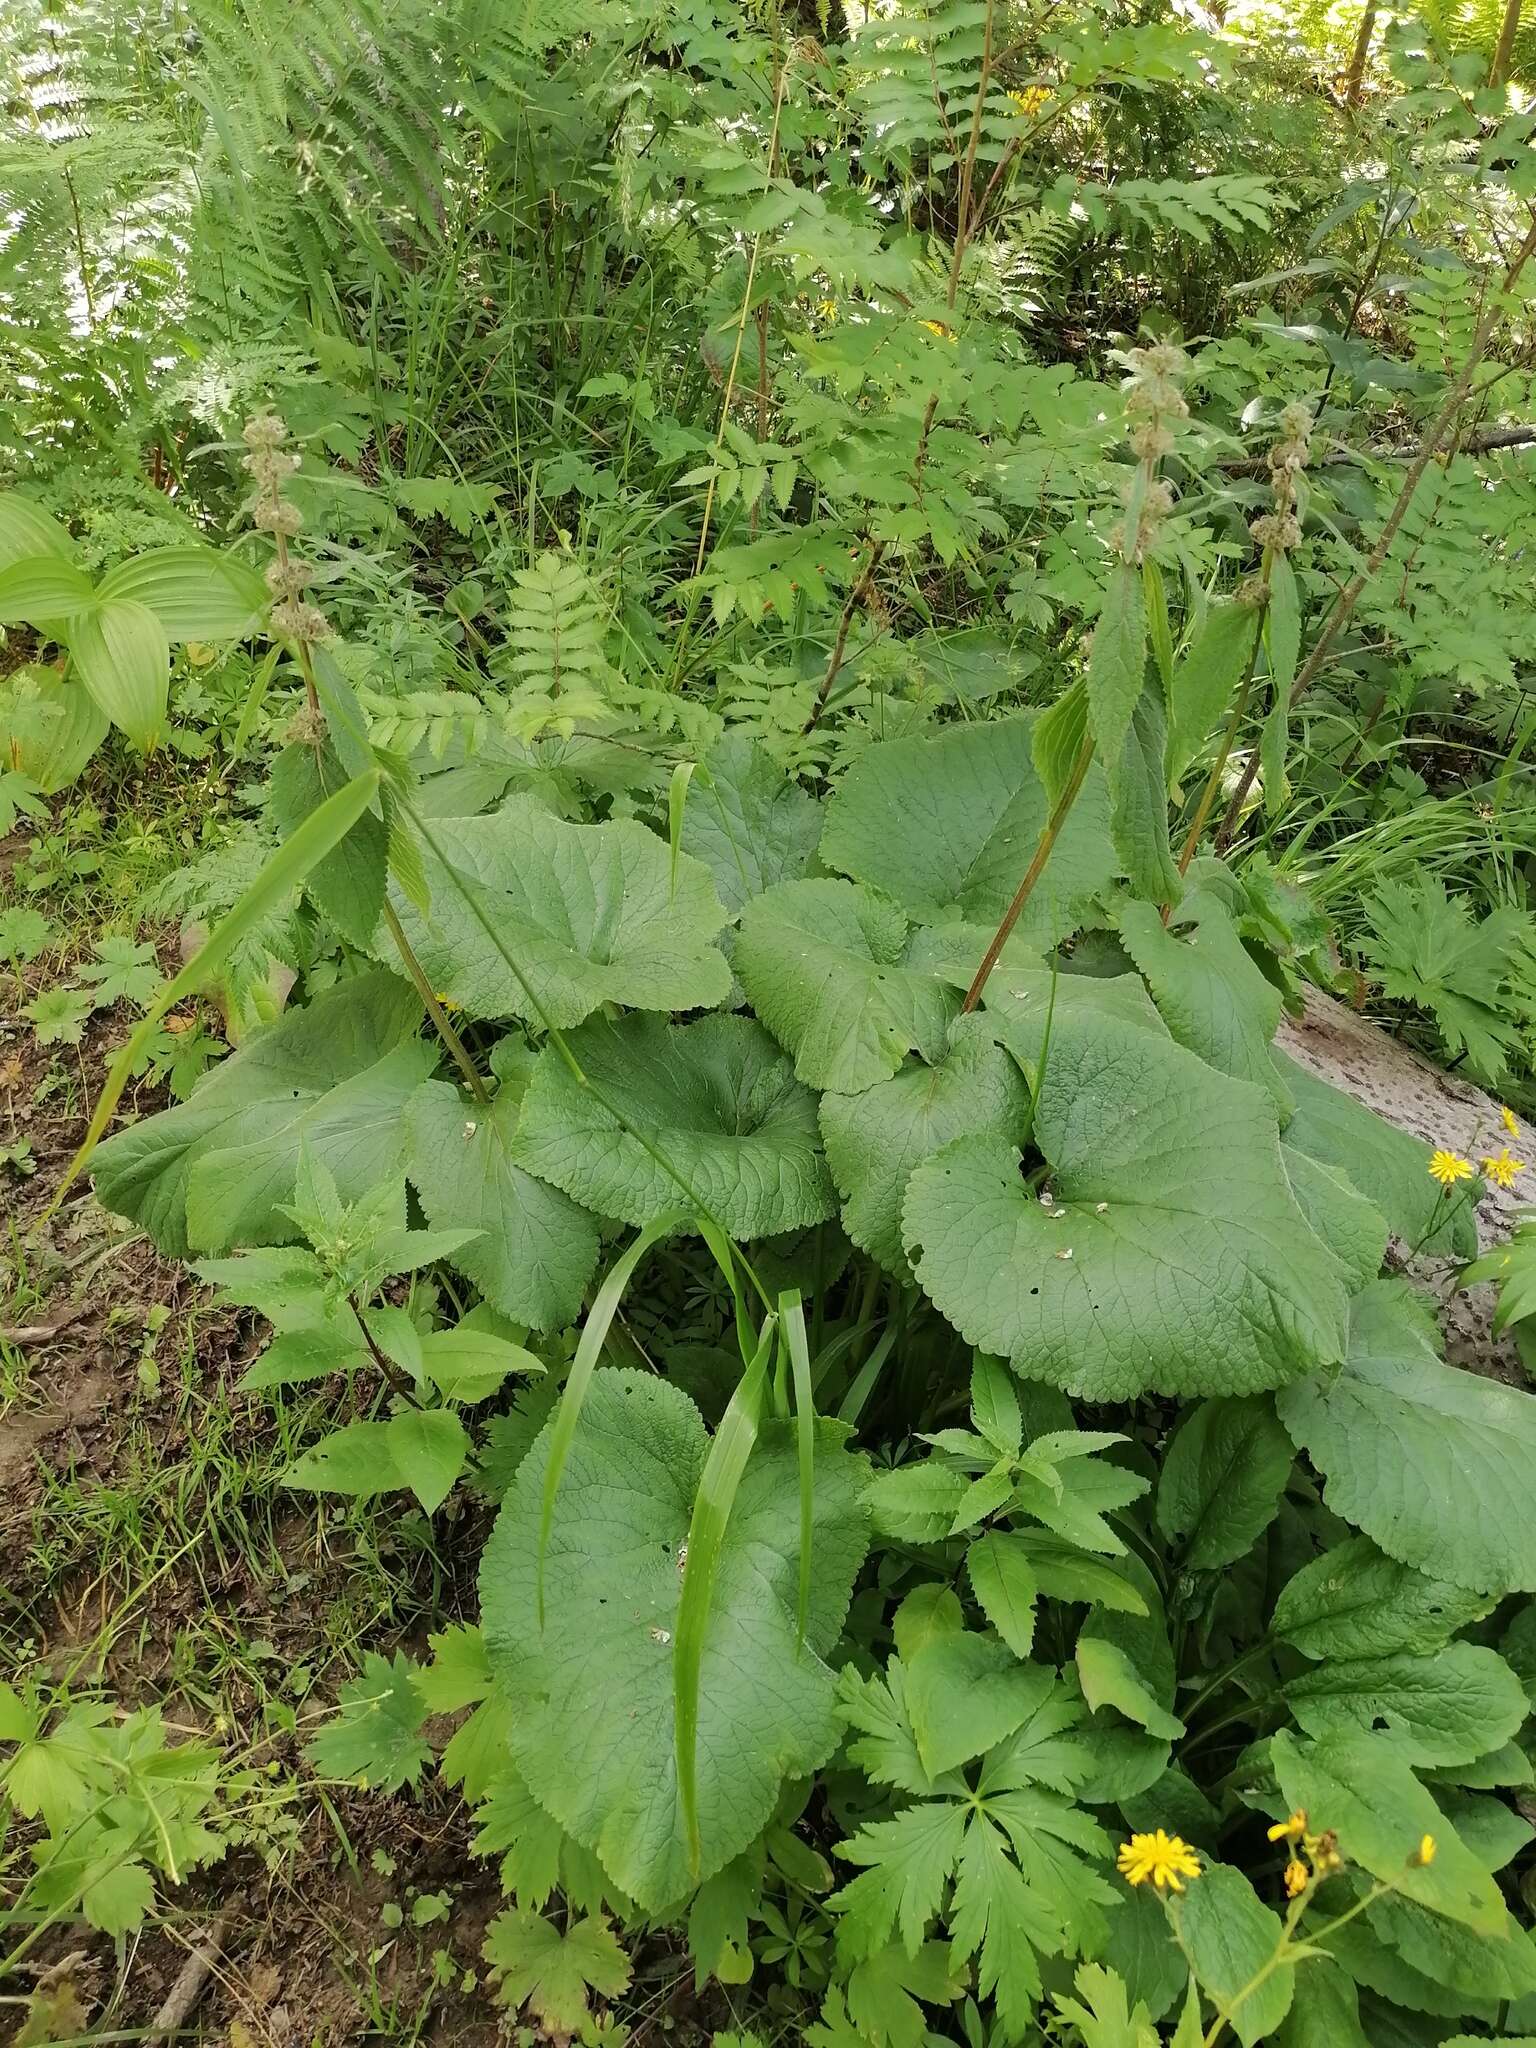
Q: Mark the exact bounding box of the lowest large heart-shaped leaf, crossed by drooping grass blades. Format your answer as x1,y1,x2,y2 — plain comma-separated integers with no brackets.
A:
479,1370,866,1911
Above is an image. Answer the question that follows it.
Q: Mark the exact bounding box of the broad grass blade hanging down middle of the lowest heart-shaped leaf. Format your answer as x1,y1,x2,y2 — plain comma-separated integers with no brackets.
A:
672,1315,778,1872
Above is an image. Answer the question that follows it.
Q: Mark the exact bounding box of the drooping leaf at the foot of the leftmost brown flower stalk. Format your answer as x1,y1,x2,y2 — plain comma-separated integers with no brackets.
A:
406,1081,598,1329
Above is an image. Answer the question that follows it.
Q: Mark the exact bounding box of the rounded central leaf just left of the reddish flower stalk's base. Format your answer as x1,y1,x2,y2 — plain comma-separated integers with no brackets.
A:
735,881,961,1094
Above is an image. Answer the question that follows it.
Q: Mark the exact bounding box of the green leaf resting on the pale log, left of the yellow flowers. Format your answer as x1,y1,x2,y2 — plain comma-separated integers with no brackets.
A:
1274,1053,1477,1260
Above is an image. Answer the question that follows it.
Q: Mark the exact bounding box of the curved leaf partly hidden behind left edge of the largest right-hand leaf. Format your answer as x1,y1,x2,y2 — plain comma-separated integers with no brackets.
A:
821,1018,1028,1274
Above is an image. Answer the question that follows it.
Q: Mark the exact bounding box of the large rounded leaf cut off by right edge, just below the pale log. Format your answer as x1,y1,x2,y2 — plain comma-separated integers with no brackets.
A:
1278,1280,1536,1593
